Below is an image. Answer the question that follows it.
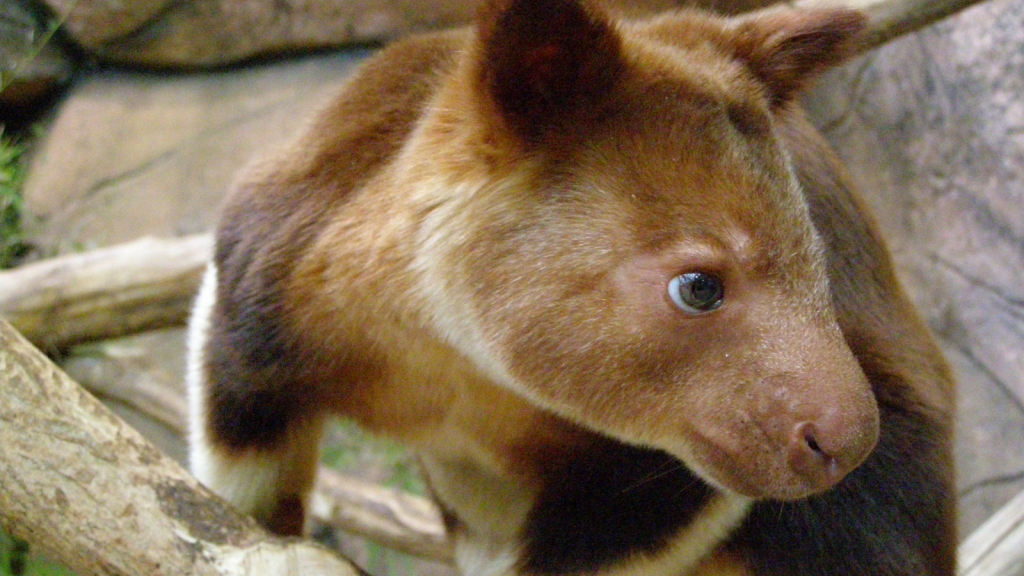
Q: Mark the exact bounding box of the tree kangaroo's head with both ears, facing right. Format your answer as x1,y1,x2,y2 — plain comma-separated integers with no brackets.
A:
414,0,879,499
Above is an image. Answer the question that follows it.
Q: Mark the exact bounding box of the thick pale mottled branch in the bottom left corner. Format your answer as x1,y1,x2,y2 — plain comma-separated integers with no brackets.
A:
0,321,358,576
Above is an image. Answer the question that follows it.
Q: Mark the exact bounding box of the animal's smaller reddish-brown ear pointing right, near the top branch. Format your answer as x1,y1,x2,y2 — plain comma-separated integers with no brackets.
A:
730,8,867,108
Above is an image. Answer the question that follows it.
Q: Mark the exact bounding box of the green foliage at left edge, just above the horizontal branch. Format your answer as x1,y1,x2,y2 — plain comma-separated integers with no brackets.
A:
0,129,29,270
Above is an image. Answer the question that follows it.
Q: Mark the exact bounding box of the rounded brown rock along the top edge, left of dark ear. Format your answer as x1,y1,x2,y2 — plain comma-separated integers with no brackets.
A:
46,0,772,68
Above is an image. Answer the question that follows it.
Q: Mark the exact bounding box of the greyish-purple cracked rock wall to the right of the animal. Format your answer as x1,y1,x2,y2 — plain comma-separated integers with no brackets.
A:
808,0,1024,530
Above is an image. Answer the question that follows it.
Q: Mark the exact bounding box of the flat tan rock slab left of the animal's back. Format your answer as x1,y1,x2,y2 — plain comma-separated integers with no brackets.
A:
25,51,364,253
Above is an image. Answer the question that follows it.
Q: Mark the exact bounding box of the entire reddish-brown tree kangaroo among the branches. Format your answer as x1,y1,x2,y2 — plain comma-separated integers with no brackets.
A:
188,0,955,575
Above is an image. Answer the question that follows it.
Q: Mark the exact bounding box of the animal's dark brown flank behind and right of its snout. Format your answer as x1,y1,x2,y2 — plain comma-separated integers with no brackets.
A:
730,106,957,576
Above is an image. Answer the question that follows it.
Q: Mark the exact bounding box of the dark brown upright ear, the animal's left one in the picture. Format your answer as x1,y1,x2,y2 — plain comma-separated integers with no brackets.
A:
477,0,624,140
